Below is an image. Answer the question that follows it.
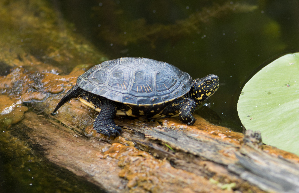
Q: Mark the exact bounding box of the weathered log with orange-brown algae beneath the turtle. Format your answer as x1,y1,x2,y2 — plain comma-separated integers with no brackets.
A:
0,67,299,192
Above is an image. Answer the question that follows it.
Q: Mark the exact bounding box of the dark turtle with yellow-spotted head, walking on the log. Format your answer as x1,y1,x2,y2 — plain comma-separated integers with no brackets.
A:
52,57,219,137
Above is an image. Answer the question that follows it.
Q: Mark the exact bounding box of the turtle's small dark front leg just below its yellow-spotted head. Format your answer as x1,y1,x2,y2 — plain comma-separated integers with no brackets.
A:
179,98,196,125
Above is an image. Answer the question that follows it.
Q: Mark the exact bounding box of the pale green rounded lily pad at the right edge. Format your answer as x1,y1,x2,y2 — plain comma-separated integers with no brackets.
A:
238,53,299,155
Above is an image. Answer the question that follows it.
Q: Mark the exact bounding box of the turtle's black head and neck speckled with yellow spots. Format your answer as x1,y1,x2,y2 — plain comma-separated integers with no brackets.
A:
190,74,219,105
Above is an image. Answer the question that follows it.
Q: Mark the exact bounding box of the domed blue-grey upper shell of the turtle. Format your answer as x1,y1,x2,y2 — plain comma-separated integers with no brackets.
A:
77,58,192,105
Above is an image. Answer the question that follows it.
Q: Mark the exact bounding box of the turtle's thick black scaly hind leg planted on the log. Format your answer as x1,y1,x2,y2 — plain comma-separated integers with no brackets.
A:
93,100,121,137
